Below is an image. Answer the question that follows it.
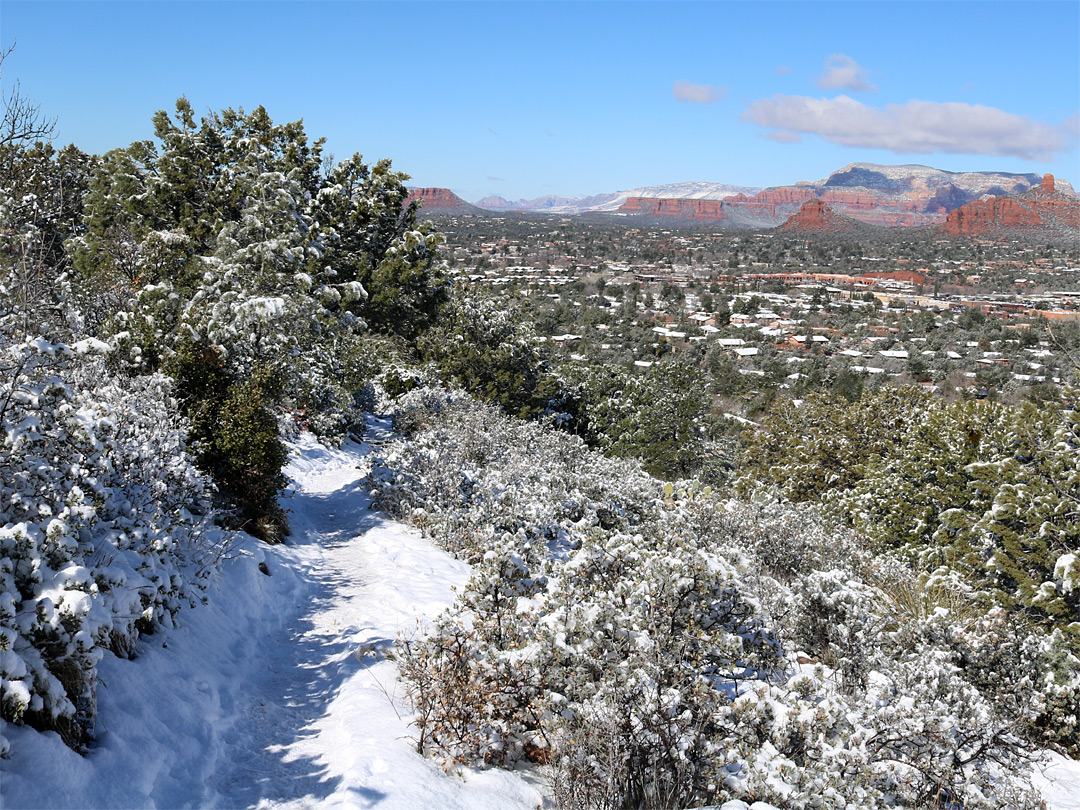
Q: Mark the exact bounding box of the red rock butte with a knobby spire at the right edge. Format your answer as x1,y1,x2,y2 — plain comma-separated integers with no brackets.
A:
942,174,1080,237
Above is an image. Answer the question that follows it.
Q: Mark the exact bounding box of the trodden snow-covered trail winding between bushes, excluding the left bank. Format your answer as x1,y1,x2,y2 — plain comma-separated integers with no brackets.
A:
204,438,539,808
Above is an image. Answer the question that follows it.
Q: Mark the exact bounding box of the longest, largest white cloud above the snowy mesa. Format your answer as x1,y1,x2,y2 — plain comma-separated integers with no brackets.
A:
742,95,1076,160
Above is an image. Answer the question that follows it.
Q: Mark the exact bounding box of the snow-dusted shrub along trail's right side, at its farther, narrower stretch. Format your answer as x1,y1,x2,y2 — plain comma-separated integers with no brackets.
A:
370,387,660,562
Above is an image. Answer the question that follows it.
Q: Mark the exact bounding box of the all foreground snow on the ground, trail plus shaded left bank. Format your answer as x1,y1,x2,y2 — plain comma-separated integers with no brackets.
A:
0,427,542,810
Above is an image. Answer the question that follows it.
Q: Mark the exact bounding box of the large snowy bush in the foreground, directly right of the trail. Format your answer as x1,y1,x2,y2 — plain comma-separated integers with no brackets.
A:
400,522,779,807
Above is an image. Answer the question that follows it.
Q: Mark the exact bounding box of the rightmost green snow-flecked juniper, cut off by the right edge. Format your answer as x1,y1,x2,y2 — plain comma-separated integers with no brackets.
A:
836,402,1080,626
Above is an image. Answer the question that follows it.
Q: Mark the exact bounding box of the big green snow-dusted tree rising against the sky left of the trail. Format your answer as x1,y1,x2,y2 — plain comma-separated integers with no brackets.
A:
62,98,447,534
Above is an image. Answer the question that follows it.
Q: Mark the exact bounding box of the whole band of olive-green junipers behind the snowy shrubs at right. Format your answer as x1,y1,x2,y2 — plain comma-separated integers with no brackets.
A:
740,389,1080,639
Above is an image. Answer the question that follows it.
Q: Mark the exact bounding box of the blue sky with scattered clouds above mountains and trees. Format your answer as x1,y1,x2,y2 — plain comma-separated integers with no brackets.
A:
0,0,1080,201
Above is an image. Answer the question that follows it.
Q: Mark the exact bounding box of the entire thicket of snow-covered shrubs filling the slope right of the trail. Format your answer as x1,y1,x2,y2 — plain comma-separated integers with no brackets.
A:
369,387,1054,810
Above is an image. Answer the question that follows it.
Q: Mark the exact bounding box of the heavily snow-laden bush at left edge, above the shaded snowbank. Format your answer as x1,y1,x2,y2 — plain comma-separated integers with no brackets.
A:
0,333,221,747
